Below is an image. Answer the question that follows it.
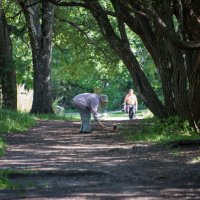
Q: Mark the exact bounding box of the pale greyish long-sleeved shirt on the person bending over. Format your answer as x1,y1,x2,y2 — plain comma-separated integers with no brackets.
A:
73,93,100,120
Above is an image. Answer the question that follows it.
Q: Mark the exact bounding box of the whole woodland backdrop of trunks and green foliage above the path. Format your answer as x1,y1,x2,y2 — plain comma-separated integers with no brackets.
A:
0,0,200,131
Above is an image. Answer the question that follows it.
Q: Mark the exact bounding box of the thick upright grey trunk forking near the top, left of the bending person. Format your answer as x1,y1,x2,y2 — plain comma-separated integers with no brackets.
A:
21,0,54,113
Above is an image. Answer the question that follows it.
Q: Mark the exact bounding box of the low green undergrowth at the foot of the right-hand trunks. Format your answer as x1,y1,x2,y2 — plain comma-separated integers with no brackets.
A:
122,117,200,143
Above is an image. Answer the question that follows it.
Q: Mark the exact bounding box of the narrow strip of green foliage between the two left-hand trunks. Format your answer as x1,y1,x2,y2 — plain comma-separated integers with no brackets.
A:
3,1,33,89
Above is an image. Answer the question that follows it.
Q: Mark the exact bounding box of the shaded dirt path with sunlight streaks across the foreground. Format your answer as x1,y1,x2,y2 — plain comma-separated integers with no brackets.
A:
0,120,200,200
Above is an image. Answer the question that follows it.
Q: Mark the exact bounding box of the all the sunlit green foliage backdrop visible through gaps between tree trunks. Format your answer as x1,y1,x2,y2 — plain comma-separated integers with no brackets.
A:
6,1,160,110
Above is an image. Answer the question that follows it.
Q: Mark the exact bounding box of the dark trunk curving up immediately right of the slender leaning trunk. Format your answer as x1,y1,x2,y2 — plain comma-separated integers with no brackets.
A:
117,2,176,116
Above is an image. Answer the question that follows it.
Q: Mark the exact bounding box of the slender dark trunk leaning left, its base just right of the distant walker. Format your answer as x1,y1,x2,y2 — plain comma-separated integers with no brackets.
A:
89,3,167,118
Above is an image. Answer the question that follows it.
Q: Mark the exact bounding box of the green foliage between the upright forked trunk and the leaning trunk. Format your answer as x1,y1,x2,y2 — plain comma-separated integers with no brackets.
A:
52,5,134,109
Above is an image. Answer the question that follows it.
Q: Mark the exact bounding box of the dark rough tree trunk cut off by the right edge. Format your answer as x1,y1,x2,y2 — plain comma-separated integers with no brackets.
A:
183,0,200,132
